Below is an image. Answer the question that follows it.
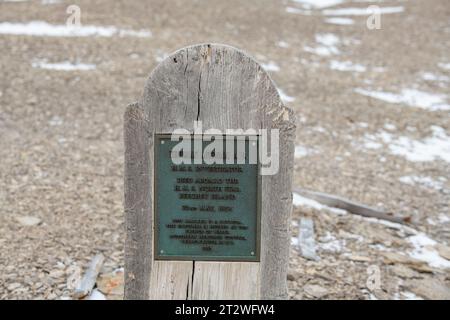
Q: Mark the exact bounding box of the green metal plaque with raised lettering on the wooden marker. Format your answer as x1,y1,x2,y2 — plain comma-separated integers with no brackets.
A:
154,134,261,261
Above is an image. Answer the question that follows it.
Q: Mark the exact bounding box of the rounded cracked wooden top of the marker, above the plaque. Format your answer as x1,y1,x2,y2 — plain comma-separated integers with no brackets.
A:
140,43,293,132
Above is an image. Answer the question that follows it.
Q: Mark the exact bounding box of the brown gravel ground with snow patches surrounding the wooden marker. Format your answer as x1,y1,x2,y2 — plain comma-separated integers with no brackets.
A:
0,0,450,299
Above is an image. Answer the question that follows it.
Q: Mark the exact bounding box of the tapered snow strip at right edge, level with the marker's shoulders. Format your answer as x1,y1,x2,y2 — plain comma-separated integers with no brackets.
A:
354,88,450,111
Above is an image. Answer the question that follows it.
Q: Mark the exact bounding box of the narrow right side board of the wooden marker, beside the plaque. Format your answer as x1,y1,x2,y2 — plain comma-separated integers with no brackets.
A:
261,108,295,299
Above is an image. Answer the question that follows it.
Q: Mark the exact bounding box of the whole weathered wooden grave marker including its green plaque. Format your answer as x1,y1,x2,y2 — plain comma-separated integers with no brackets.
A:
124,44,295,299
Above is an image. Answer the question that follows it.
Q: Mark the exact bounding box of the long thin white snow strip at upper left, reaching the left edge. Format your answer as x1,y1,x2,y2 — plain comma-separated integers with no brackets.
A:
0,21,152,38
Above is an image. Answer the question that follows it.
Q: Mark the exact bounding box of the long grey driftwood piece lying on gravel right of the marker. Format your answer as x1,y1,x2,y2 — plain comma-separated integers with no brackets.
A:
293,188,410,224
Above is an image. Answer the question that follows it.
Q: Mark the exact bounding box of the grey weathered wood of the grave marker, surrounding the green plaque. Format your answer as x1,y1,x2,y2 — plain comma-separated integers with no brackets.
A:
124,44,295,299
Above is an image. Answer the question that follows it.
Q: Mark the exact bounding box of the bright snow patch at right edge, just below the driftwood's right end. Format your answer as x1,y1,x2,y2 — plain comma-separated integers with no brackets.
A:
407,233,450,269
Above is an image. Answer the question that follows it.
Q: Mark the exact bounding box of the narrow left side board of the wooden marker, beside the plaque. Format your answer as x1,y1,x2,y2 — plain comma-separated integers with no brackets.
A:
124,103,152,299
